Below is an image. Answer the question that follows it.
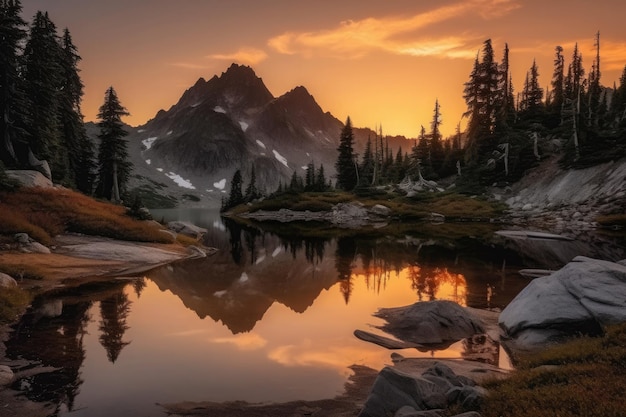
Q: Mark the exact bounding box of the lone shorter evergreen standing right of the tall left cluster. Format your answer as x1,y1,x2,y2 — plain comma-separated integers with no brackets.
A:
96,87,132,202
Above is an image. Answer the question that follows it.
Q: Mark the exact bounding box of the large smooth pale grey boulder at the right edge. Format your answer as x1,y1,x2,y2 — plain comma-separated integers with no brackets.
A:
499,256,626,350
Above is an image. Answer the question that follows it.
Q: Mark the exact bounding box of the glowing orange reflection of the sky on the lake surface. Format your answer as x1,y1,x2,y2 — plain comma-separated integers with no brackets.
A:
64,268,472,416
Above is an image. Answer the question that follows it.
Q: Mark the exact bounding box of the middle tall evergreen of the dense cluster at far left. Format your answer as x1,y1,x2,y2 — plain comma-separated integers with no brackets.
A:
24,12,63,181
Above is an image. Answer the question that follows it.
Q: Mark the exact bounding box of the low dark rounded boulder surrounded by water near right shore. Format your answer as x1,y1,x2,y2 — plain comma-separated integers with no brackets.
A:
375,300,485,350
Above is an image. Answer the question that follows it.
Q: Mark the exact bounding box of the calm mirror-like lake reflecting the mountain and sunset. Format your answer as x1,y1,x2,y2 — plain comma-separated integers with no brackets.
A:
7,210,624,417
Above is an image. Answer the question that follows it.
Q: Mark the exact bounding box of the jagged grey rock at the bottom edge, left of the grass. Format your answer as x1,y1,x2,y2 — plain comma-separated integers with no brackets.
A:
359,363,486,417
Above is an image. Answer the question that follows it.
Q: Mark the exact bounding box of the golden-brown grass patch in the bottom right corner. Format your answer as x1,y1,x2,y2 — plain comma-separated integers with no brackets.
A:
480,323,626,417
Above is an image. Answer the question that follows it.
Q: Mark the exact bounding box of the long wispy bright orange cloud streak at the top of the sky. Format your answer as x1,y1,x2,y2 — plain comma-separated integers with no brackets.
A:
268,0,521,59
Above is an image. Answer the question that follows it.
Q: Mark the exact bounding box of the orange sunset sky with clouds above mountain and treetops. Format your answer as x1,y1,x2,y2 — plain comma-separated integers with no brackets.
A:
22,0,626,137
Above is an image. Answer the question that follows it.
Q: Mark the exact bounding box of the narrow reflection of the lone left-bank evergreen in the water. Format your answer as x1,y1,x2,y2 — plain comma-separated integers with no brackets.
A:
98,290,132,363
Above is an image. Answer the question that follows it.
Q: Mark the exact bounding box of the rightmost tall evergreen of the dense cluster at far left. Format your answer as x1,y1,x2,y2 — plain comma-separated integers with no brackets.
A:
59,29,95,194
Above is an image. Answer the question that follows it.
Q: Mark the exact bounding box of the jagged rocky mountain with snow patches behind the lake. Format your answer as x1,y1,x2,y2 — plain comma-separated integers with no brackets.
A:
120,64,413,207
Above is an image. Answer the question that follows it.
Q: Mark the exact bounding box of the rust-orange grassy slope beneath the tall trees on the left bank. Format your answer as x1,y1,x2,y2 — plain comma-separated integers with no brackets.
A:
0,188,173,244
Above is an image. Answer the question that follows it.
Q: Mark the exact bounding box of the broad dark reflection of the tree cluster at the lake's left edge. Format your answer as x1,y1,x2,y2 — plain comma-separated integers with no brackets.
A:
6,299,92,413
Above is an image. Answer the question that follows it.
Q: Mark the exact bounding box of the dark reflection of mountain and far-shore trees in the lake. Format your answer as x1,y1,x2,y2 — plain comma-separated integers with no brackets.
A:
150,221,572,333
